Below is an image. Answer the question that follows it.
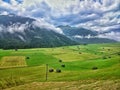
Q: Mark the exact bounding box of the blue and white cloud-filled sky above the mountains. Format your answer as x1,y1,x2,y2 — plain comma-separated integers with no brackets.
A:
0,0,120,39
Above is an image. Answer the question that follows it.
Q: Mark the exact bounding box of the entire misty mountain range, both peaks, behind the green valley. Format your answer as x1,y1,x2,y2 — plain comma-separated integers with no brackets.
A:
0,14,116,49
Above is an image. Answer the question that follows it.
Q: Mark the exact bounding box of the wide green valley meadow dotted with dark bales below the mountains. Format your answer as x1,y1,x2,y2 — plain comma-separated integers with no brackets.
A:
0,43,120,90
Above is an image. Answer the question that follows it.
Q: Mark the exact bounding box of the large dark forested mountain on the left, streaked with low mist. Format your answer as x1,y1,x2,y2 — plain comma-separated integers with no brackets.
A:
0,14,77,49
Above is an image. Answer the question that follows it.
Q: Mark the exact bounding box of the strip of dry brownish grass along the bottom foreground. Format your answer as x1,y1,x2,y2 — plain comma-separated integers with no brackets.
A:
6,80,120,90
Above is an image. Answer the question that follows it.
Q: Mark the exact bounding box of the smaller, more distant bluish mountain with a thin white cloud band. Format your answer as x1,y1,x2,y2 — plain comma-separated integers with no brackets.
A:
58,25,116,43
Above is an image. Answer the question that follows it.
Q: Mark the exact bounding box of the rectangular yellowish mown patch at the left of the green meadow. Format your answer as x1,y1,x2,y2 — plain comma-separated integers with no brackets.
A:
0,56,27,68
